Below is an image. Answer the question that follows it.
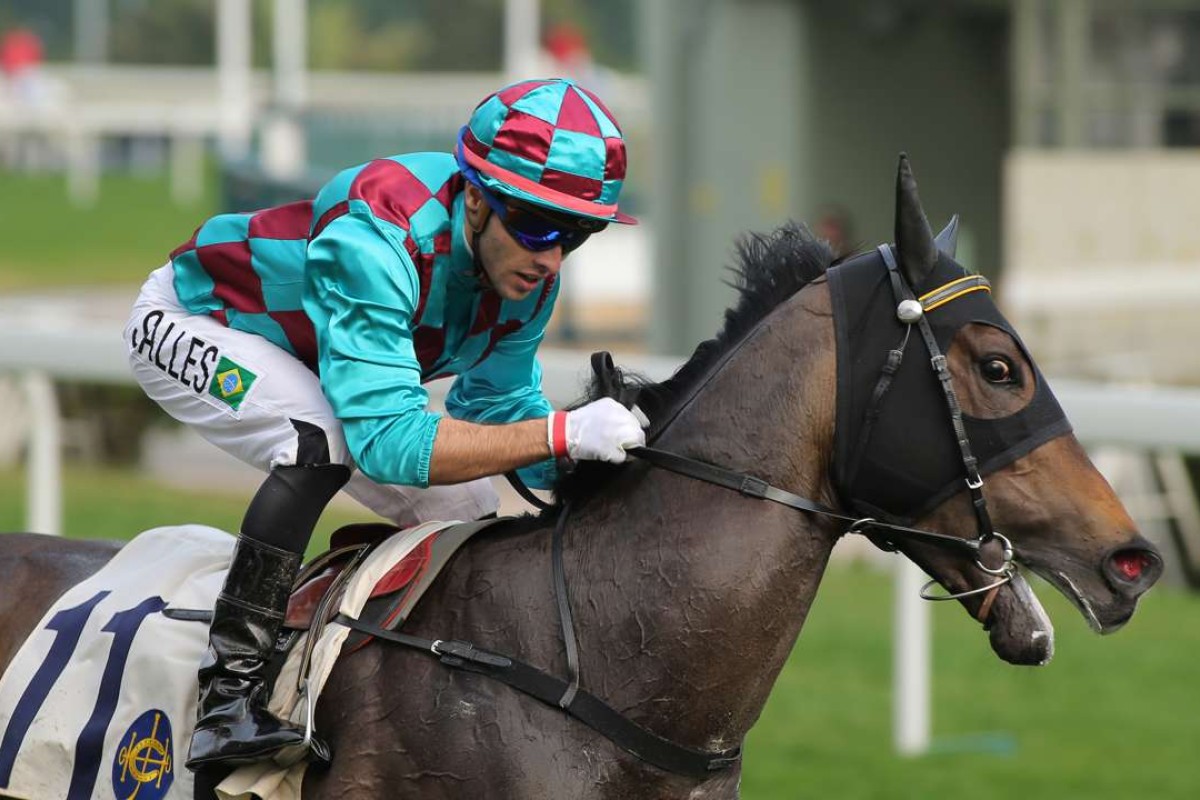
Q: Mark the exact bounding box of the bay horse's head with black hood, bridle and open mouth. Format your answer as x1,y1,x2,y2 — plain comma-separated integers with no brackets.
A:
830,156,1162,663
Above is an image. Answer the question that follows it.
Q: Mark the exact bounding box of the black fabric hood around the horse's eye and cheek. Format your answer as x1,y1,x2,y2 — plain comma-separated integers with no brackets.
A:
828,251,1070,523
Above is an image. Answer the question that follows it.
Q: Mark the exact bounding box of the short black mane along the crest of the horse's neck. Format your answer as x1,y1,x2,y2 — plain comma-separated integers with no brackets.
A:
554,222,834,503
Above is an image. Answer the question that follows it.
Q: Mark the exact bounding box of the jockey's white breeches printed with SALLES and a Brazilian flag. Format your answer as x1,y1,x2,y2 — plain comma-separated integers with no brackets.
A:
125,264,499,527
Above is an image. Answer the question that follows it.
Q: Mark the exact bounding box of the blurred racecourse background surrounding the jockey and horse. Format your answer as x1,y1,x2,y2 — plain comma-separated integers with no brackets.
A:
0,0,1200,799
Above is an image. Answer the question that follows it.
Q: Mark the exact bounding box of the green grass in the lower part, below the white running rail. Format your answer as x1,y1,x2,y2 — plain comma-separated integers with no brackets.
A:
0,469,1200,800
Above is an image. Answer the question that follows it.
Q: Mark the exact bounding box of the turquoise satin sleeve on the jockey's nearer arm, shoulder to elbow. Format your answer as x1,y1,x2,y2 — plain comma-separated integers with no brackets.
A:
304,210,442,487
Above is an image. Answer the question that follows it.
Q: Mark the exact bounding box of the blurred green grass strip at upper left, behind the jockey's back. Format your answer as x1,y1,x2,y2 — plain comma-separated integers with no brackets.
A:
0,170,216,291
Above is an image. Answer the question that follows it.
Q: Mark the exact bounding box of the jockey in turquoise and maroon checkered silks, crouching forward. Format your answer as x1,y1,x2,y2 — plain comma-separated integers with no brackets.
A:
125,79,644,770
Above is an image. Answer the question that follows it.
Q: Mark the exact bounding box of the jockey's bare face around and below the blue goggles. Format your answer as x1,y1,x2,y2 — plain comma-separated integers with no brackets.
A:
466,184,563,300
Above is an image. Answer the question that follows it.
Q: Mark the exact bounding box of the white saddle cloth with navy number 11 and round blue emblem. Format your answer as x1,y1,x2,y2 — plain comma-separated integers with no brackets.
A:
0,525,234,800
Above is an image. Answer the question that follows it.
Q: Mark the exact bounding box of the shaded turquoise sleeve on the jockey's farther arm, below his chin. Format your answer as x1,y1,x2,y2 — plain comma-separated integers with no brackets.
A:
445,275,559,488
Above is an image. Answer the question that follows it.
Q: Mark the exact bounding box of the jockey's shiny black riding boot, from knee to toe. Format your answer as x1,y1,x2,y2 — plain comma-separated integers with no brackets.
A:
187,464,349,770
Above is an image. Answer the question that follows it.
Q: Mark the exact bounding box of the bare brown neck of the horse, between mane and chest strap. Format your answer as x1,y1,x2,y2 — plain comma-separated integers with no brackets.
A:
574,284,835,747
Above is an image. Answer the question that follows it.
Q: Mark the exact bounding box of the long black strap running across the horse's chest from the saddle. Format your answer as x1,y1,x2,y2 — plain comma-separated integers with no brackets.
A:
332,614,742,778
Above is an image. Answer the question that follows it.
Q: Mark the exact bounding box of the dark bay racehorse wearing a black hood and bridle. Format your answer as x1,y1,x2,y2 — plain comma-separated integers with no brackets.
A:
0,157,1162,800
